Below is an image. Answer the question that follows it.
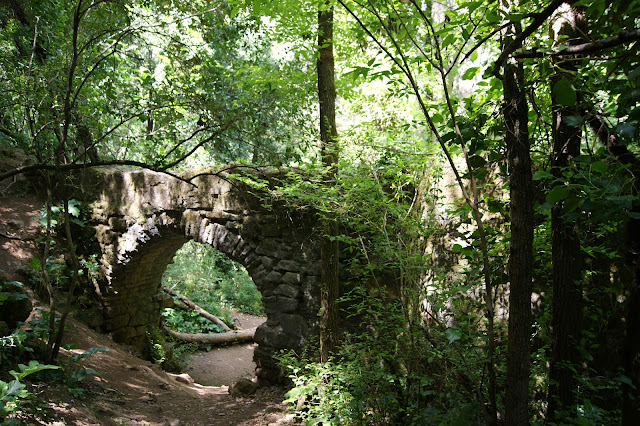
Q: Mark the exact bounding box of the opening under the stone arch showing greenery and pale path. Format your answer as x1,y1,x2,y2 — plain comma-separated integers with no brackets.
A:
161,240,266,386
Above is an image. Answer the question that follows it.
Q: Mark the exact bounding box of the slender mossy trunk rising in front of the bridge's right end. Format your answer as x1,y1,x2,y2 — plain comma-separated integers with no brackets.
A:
317,3,339,362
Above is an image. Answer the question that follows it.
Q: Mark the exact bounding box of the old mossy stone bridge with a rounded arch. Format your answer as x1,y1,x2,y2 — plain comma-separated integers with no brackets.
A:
84,168,320,381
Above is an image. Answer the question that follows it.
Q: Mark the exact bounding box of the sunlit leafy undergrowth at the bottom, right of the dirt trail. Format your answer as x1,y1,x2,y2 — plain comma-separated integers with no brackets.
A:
278,288,482,425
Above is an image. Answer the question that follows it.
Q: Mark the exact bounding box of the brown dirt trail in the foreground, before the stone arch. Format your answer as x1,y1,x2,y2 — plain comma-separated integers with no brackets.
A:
33,314,293,426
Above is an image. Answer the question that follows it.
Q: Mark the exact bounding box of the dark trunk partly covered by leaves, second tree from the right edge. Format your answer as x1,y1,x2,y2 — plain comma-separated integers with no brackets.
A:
547,8,582,422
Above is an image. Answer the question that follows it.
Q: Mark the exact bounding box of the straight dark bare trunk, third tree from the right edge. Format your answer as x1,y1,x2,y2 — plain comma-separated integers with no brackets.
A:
503,53,534,425
